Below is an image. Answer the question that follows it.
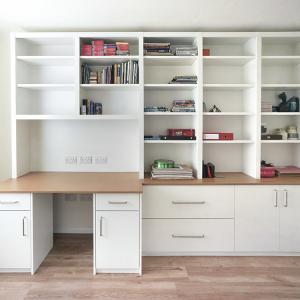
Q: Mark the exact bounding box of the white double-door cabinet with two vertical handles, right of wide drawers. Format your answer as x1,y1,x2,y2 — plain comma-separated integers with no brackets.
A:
235,186,300,252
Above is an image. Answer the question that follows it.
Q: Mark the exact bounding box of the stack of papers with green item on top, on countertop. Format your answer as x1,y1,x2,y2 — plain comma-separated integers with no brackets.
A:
151,160,193,179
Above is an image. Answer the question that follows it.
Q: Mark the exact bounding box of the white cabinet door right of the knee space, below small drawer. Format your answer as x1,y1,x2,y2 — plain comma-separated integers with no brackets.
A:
95,211,140,272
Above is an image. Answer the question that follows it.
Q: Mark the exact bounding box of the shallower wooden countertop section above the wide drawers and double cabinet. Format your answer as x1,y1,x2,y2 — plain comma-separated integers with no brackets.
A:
143,172,300,185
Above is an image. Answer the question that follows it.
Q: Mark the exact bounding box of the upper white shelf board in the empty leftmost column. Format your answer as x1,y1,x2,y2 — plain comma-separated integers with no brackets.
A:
17,56,75,66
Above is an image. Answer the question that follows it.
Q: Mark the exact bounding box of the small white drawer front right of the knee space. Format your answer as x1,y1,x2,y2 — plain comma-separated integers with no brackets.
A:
96,194,140,210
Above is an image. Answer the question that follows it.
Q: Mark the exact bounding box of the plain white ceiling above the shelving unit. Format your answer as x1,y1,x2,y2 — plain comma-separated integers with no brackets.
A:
0,0,300,31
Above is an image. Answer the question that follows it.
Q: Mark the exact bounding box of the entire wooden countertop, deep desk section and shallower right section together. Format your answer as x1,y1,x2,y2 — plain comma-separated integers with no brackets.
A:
0,172,300,194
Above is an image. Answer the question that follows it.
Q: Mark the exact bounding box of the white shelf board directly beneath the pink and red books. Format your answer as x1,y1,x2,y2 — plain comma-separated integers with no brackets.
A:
80,55,139,65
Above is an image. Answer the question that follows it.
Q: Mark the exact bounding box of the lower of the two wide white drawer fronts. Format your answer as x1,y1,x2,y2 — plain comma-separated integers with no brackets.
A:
143,219,234,255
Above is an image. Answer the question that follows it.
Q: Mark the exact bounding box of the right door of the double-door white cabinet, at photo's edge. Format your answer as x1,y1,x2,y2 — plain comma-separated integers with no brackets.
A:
280,186,300,252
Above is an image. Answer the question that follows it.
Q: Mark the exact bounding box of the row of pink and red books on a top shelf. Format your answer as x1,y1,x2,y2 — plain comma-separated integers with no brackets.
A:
81,40,130,56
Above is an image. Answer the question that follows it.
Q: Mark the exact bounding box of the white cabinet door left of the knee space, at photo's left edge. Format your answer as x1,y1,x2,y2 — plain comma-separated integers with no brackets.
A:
0,211,31,269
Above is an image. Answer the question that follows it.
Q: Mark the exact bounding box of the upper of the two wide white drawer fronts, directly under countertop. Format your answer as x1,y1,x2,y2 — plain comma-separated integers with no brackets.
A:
143,186,234,218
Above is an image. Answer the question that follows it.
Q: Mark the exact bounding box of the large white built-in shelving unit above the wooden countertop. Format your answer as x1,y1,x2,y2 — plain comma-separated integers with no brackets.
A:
11,32,300,178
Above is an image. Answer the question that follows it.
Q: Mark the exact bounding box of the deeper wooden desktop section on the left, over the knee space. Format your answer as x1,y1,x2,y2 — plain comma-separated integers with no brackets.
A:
0,172,143,194
